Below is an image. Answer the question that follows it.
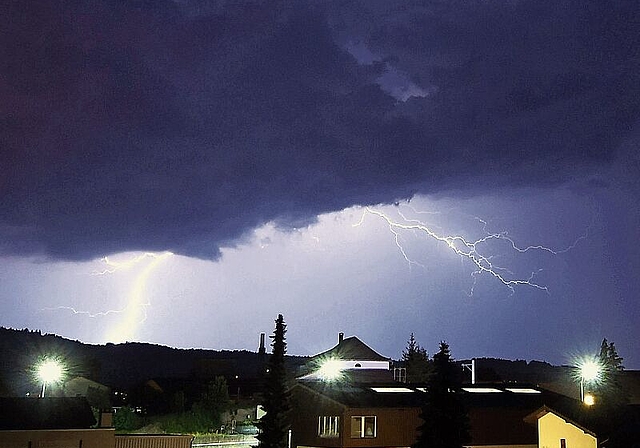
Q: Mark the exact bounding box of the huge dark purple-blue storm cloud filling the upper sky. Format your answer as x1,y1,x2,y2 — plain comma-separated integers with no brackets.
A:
0,0,640,258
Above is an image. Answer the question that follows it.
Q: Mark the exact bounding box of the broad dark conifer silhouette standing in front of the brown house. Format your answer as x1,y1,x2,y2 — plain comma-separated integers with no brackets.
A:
413,341,470,448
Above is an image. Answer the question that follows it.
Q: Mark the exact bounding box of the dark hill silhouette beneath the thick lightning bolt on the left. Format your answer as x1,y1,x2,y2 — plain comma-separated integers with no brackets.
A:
0,327,307,396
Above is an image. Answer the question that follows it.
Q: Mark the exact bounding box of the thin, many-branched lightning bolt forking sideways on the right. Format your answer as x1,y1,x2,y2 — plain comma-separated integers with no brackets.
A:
353,204,587,296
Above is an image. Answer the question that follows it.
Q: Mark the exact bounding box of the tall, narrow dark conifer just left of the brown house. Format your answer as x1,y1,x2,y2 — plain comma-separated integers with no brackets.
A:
257,314,291,448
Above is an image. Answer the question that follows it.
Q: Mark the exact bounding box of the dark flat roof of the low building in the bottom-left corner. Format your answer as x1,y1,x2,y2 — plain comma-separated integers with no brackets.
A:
0,397,96,430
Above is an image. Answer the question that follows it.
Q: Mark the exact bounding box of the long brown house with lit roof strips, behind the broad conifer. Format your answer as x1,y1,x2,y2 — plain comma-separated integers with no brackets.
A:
292,381,570,448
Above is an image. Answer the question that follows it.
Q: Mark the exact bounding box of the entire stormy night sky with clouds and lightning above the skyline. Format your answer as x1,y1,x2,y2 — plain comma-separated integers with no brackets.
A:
0,0,640,369
